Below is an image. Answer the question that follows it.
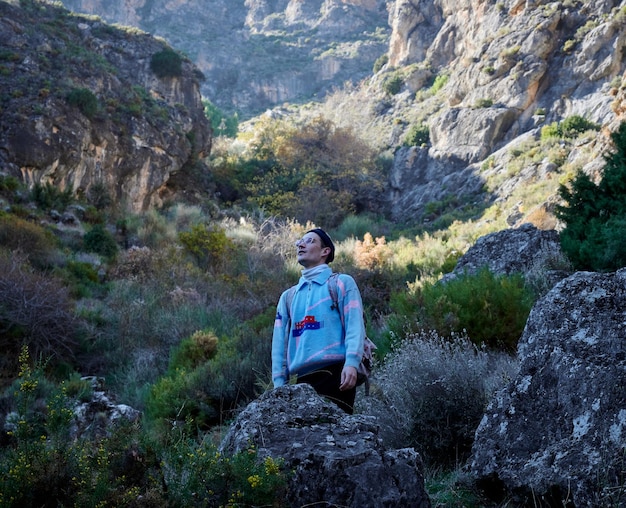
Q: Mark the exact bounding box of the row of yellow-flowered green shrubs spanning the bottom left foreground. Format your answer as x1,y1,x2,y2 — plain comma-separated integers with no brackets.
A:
0,348,287,508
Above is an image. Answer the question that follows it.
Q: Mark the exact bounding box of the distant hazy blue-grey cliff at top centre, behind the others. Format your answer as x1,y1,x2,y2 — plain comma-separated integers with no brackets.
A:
63,0,389,116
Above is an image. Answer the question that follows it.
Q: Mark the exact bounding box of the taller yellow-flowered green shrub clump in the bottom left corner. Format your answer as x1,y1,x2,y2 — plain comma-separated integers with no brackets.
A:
0,350,167,507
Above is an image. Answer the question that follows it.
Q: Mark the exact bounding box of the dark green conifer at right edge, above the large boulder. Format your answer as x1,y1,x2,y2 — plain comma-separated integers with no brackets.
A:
556,123,626,271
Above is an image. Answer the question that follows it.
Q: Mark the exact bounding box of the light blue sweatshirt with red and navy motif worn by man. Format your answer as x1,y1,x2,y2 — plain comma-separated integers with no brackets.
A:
272,265,365,387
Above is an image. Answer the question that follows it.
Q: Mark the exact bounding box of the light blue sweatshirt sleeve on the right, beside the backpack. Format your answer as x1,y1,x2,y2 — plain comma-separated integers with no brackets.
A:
338,274,365,369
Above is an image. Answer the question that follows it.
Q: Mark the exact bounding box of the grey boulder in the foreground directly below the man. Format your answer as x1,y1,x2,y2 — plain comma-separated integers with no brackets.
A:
221,384,430,508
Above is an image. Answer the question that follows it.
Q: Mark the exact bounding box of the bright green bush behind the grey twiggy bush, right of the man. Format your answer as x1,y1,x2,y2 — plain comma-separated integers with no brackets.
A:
390,268,534,352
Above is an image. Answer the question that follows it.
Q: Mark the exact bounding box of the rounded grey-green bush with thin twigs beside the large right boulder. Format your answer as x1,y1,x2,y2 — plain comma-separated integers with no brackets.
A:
364,332,517,467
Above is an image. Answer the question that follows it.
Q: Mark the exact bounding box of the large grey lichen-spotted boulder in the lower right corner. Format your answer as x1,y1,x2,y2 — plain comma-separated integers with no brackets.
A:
470,269,626,507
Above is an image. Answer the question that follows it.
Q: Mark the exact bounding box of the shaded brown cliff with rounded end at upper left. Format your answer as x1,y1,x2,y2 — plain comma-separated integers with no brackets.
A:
0,1,211,211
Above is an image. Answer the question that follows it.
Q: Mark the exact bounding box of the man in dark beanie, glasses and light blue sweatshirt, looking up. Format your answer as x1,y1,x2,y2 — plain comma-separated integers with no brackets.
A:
272,228,365,414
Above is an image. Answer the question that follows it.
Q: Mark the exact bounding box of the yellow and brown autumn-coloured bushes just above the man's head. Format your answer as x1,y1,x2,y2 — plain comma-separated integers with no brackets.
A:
240,117,384,228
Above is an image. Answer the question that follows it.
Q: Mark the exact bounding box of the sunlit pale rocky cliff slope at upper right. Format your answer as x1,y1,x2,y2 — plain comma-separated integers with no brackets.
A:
310,0,626,228
